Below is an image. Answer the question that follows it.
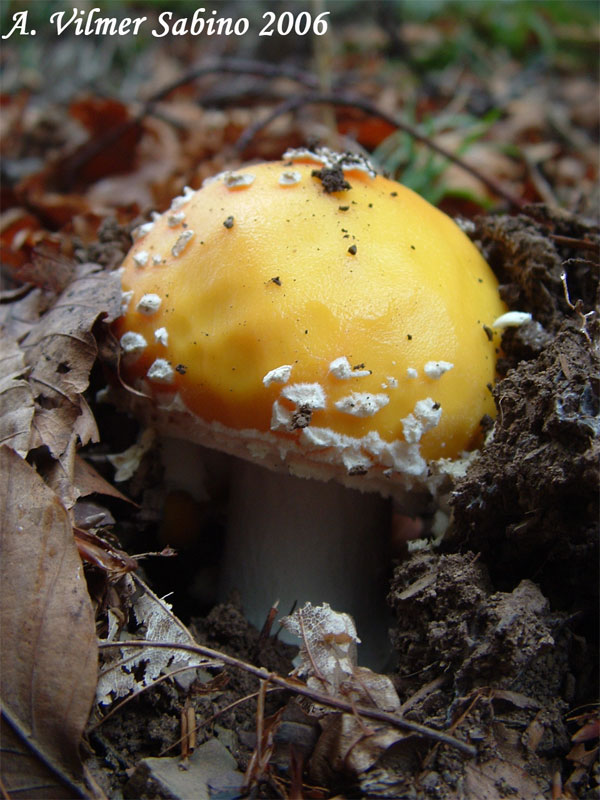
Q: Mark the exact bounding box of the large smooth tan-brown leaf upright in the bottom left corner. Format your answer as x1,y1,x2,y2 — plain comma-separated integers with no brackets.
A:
0,447,97,800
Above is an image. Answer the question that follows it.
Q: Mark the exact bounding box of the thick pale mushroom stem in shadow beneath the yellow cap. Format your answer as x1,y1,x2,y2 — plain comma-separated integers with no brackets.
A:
220,459,391,669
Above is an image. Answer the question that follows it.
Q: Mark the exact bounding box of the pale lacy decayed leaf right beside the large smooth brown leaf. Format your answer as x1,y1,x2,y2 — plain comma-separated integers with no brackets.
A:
96,575,221,705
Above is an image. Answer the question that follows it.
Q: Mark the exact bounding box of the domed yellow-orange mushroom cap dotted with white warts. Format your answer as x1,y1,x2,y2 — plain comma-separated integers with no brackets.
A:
114,151,506,488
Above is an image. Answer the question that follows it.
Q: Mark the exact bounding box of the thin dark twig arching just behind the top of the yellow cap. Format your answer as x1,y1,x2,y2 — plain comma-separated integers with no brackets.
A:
235,92,527,214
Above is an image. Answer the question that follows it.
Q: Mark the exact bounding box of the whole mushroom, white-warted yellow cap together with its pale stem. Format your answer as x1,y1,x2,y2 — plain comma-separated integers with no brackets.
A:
109,149,506,663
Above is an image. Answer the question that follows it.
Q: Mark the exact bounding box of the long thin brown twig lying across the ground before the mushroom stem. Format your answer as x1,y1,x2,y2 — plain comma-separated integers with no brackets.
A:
98,639,477,756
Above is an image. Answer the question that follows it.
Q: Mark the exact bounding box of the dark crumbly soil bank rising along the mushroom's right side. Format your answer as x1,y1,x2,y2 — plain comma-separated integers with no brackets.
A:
382,209,600,797
